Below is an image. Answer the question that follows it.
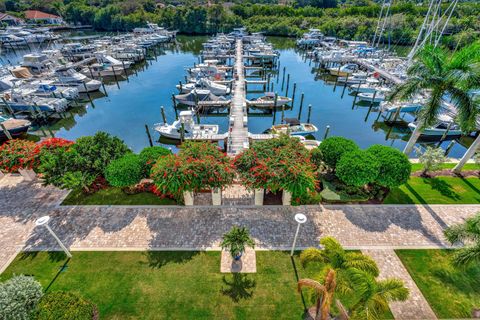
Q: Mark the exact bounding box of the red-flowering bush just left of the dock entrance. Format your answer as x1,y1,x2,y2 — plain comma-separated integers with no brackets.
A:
151,142,235,197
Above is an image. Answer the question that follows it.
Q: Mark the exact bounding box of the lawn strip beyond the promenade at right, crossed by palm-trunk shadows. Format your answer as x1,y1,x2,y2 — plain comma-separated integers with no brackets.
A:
383,177,480,204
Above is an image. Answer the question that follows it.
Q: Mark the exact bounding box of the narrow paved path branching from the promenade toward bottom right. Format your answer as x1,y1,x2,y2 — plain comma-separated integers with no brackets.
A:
363,249,437,320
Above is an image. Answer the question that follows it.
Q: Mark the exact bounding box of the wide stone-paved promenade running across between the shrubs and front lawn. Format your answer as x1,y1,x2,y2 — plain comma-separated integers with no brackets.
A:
0,176,480,319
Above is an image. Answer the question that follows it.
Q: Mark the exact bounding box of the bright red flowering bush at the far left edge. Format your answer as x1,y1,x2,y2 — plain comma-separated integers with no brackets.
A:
0,139,38,172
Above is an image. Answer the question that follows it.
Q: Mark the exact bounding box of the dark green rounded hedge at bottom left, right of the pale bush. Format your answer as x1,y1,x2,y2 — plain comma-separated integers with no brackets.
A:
35,291,98,320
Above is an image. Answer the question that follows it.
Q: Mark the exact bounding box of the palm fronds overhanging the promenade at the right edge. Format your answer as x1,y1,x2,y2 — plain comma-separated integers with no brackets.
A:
444,214,480,267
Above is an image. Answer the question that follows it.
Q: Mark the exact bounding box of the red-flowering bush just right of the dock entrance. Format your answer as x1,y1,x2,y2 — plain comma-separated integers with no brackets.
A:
234,135,317,197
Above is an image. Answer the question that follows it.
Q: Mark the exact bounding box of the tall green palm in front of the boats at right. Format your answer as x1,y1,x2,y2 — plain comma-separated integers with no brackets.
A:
389,43,480,154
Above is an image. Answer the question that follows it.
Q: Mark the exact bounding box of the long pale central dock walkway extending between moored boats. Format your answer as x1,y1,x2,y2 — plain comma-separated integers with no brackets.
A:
227,39,249,156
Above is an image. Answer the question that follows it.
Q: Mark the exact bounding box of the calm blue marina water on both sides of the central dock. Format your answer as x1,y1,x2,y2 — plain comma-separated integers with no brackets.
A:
0,36,472,156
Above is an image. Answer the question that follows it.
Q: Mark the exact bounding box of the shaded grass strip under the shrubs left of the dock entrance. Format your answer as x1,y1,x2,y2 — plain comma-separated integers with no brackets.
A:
62,187,176,205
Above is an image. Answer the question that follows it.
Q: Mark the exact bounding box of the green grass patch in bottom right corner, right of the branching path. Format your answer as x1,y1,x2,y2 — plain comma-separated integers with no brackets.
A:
396,250,480,318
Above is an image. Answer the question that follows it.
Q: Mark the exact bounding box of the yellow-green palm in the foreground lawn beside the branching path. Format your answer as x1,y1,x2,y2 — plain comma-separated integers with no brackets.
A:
299,237,408,320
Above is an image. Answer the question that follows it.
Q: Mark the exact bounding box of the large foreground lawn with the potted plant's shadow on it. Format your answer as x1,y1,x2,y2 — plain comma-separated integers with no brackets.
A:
0,251,393,320
